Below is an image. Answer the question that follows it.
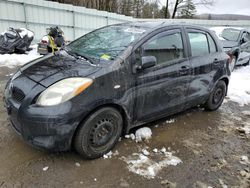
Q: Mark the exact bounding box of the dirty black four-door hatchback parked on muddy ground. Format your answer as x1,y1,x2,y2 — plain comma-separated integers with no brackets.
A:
4,22,230,158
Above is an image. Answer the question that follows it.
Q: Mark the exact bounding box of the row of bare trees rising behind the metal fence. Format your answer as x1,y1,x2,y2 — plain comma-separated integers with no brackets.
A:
50,0,214,18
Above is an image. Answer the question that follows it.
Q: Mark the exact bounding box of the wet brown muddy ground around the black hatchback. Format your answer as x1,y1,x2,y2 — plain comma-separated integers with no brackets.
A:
0,67,250,188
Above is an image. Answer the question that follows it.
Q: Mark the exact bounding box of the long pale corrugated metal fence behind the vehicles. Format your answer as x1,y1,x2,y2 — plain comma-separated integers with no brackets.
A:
0,0,250,42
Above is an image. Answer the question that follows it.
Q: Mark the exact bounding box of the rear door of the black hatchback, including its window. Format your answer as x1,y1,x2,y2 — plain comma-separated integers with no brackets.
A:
187,28,225,107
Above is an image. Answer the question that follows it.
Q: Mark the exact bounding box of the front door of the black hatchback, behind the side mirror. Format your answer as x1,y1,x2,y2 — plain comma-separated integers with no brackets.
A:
135,29,191,121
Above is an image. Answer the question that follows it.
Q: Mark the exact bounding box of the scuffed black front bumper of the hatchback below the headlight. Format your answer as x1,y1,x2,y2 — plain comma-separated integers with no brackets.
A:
5,97,80,151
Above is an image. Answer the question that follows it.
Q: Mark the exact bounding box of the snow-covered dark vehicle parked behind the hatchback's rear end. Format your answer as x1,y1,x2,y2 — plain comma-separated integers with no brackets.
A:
210,27,250,71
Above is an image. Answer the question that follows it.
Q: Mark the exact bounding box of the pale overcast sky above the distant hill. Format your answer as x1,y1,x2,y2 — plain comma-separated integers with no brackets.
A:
160,0,250,15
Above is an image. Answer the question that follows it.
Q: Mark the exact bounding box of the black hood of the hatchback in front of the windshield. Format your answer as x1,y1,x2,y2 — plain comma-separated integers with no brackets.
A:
20,52,101,87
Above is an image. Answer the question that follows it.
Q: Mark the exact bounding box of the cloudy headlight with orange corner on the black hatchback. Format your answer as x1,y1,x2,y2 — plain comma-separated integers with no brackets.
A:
36,77,93,106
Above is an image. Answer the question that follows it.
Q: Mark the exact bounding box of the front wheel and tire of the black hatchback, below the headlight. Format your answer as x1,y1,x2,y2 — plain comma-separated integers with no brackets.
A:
74,107,123,159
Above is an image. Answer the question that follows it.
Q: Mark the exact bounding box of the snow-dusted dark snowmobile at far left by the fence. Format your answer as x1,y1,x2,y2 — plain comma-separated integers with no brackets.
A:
0,27,34,54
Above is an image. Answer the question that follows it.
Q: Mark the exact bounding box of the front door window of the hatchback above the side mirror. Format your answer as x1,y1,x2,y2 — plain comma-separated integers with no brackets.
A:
143,32,184,64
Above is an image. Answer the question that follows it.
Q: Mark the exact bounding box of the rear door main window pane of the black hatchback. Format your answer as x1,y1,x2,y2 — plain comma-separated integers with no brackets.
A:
188,32,209,56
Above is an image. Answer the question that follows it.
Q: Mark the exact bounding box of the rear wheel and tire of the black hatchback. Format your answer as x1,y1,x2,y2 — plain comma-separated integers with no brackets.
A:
205,80,227,111
